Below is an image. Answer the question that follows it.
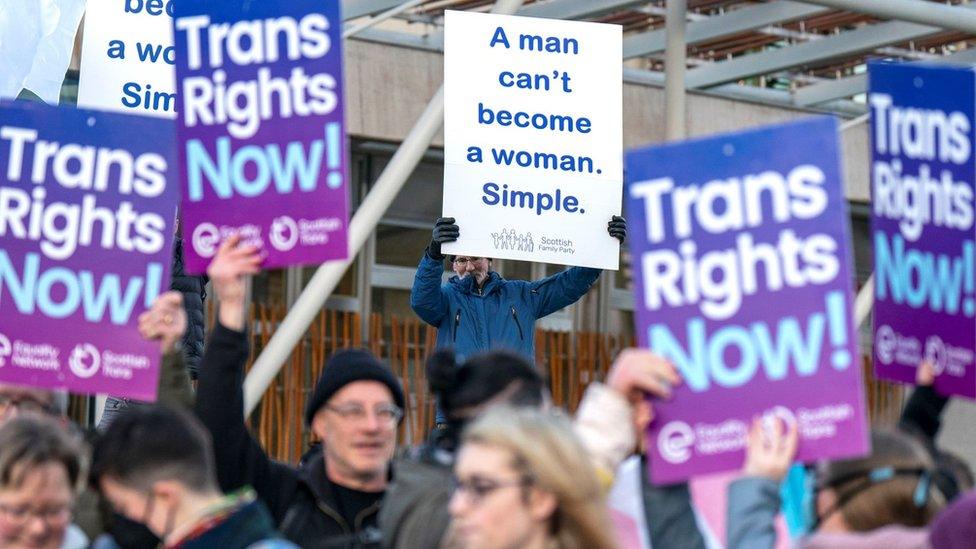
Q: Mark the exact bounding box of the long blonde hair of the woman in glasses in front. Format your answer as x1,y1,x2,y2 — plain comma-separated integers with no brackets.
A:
462,405,616,549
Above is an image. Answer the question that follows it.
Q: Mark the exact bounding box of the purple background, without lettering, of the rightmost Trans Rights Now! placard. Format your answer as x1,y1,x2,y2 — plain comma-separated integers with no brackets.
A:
868,63,976,398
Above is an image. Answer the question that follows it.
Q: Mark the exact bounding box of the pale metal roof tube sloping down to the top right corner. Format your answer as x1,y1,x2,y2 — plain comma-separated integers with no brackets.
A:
804,0,976,34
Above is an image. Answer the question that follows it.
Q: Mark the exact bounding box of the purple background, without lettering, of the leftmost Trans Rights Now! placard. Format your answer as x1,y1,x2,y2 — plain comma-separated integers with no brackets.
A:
0,103,179,400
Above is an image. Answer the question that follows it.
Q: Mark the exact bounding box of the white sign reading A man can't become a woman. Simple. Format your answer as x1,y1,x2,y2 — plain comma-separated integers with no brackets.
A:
443,11,623,269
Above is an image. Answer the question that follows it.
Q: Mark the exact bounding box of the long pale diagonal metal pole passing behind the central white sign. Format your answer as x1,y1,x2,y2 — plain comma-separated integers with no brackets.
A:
244,0,522,417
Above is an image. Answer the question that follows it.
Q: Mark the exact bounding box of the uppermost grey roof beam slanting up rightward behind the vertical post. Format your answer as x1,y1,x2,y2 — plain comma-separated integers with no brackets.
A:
624,1,830,59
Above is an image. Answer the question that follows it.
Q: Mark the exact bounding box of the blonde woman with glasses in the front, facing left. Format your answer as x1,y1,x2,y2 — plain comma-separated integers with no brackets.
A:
447,406,614,549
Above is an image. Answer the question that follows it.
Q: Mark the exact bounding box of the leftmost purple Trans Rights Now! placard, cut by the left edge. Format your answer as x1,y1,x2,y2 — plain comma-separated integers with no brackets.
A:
0,103,179,400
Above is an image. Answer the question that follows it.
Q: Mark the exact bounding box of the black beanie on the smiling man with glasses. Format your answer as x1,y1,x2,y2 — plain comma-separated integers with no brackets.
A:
305,349,405,425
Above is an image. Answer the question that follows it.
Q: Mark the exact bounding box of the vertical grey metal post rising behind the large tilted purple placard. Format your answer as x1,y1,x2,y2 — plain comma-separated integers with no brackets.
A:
664,0,688,140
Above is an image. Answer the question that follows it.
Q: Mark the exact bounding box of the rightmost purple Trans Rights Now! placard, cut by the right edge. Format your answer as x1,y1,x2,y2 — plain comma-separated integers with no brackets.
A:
868,63,976,398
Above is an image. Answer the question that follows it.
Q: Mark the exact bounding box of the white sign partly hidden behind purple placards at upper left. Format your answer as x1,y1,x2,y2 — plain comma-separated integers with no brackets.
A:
78,0,176,118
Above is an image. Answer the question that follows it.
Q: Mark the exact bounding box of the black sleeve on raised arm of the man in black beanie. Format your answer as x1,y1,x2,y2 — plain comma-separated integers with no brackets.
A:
195,322,299,523
